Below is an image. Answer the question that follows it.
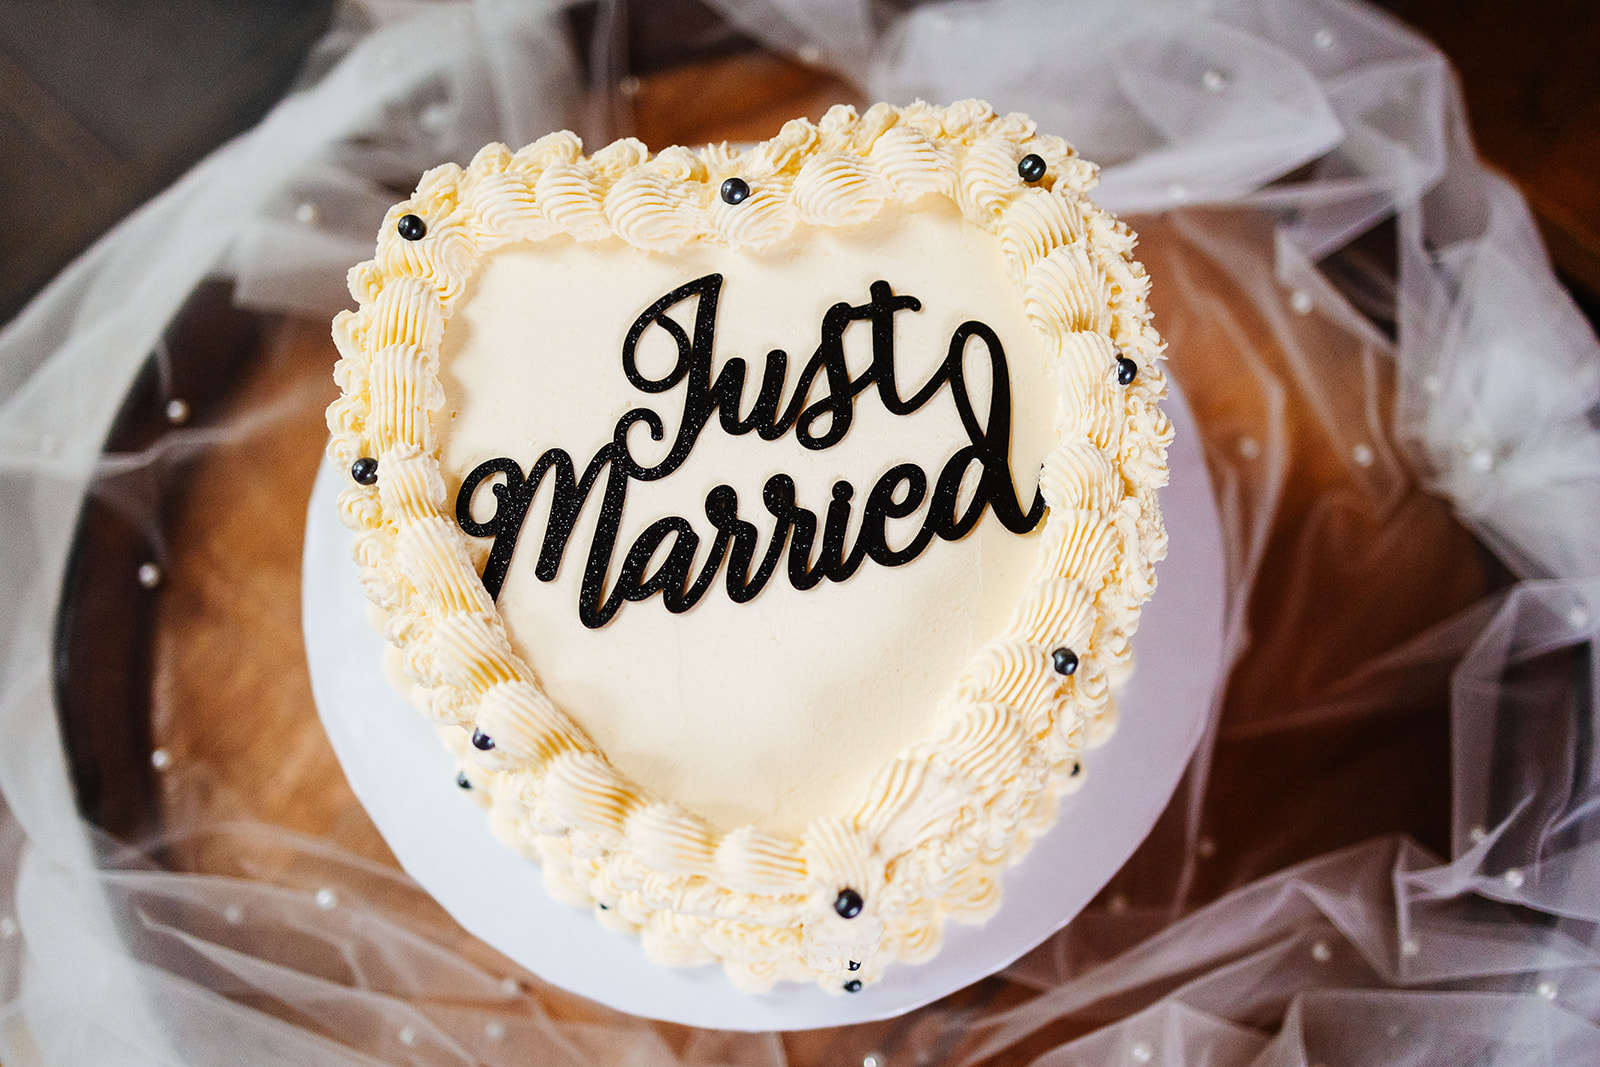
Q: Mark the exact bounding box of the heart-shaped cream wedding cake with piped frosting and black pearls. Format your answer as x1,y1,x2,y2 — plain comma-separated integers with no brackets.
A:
328,101,1171,992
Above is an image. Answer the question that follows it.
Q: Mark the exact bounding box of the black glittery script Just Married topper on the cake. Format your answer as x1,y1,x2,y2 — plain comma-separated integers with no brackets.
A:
456,271,1045,629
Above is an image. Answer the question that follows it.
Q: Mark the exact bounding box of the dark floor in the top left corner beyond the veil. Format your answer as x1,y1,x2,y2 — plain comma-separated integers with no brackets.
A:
0,0,333,322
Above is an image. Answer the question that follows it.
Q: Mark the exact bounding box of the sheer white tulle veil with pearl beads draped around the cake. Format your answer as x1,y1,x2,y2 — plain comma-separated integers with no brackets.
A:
0,0,1600,1064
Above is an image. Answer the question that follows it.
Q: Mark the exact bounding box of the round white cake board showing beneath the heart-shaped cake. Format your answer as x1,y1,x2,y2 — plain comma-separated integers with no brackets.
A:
302,379,1222,1030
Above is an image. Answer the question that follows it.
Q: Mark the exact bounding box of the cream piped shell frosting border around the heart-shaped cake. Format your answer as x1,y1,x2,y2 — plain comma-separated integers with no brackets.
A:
328,101,1171,992
